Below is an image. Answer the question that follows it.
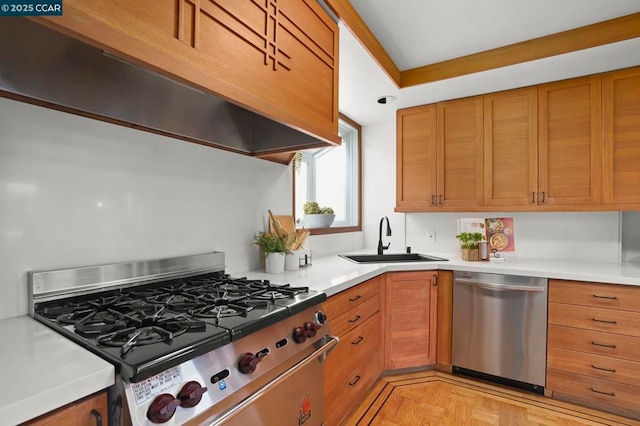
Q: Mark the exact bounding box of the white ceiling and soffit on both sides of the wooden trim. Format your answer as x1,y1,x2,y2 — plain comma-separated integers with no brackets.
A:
339,0,640,125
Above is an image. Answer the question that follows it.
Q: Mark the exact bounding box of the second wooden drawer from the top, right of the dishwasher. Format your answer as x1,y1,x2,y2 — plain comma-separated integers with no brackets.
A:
549,303,640,337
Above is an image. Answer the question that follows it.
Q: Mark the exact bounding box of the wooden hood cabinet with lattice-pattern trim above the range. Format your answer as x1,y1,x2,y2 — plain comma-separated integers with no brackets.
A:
37,0,340,143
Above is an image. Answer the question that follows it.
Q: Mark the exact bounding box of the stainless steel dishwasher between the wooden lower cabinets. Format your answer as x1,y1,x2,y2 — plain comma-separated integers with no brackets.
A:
451,272,548,393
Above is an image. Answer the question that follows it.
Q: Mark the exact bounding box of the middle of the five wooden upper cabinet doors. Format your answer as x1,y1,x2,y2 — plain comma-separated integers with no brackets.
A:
484,87,538,207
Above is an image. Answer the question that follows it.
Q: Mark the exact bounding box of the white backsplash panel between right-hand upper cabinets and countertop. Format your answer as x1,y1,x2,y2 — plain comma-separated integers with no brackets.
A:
406,212,621,262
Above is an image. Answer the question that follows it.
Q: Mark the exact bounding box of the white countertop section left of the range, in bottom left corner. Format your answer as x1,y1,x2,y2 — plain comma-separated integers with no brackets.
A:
0,315,115,426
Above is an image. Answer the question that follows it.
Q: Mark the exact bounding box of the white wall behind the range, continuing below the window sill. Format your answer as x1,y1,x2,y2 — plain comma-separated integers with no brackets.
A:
0,98,361,319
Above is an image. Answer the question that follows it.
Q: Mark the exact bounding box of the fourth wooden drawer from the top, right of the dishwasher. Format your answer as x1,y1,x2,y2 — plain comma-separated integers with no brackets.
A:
547,348,640,385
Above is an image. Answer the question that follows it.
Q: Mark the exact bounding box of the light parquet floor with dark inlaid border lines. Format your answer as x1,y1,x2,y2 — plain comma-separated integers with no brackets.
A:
344,371,640,426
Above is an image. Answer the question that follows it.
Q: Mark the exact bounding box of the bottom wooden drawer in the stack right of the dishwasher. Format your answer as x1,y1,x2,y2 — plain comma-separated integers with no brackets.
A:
547,369,640,412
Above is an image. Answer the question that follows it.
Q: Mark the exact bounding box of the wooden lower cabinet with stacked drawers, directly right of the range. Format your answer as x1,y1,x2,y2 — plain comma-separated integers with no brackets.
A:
324,277,383,426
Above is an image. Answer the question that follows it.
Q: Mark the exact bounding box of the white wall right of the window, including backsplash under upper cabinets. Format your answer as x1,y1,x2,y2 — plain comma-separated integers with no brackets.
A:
363,115,624,261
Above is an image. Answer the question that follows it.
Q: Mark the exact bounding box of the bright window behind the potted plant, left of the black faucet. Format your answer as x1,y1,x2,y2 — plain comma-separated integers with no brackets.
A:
293,115,361,234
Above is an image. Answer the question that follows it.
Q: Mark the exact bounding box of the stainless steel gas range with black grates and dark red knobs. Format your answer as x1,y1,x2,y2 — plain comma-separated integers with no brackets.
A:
29,252,338,425
